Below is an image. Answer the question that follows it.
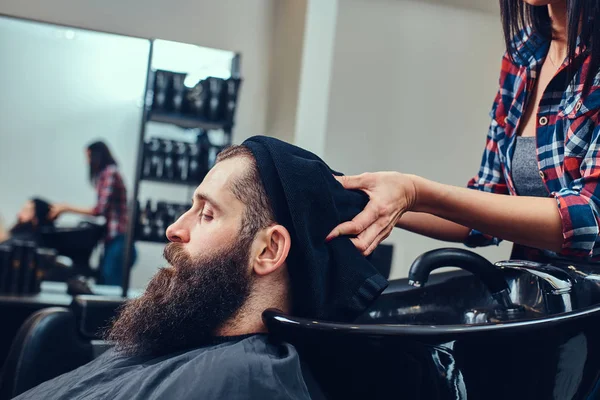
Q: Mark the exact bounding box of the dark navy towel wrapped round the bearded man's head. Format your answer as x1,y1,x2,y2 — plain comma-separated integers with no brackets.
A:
243,136,387,321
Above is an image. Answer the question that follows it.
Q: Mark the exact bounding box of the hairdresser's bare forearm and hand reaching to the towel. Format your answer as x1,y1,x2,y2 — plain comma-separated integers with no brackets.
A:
328,172,563,254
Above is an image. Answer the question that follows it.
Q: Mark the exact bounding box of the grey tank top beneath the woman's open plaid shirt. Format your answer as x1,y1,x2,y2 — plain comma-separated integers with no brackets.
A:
512,136,550,197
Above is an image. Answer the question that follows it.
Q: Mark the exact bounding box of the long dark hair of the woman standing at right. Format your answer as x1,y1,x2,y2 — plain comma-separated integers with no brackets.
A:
500,0,600,95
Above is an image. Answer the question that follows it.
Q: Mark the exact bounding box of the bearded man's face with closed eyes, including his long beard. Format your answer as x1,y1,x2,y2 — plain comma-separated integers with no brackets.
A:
106,158,254,356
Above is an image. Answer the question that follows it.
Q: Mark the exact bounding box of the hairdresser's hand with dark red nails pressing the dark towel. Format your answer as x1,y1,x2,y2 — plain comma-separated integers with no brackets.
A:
327,172,417,255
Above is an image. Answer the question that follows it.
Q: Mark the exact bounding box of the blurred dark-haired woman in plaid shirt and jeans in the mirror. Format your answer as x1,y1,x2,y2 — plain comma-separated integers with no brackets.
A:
50,141,135,285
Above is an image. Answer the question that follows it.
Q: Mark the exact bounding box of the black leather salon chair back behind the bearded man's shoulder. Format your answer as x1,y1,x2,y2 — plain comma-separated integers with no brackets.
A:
0,296,123,400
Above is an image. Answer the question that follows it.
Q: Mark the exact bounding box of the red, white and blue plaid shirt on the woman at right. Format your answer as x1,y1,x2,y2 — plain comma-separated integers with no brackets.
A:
466,32,600,261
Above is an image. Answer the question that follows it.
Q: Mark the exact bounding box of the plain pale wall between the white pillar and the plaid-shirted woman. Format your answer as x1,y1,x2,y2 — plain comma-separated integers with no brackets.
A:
325,0,509,277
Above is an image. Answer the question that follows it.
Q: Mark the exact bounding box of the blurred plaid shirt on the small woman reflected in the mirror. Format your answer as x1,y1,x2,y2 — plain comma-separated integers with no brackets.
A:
94,165,127,243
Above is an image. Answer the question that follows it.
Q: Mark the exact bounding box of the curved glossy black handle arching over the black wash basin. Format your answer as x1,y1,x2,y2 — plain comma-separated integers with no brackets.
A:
408,248,518,310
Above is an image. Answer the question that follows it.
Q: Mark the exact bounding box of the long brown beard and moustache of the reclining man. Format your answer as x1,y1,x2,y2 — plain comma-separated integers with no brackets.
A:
105,239,253,356
